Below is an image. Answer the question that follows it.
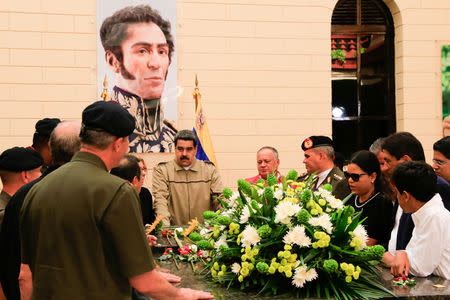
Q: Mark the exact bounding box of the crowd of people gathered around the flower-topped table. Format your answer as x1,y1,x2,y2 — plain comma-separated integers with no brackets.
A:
0,101,450,299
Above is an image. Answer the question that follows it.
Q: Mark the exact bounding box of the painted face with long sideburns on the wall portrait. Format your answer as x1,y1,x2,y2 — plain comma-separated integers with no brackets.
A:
107,23,169,99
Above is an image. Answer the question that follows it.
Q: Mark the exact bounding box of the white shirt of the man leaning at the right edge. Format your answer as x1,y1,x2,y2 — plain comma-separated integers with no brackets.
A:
405,194,450,279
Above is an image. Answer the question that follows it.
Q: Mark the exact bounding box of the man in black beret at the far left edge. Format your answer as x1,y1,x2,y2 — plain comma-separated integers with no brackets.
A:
0,147,44,228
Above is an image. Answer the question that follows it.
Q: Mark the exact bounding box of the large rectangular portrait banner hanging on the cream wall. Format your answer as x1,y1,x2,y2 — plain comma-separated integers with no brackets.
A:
97,0,178,153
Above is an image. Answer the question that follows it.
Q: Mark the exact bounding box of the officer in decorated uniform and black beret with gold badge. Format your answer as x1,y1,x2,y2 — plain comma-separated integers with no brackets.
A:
298,135,350,199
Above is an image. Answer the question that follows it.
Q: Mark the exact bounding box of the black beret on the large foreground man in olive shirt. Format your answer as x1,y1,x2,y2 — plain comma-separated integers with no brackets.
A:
82,101,135,137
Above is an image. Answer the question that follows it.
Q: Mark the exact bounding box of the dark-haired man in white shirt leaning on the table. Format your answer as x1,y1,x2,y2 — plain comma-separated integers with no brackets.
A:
383,161,450,279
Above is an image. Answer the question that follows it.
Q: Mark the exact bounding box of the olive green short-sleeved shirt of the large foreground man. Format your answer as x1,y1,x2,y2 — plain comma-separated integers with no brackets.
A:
20,152,154,300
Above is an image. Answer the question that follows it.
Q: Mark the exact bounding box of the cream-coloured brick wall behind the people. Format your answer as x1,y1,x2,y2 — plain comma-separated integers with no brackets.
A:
0,0,450,190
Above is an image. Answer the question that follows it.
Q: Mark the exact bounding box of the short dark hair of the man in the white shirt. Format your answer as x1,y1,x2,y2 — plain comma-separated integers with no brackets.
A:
392,161,437,202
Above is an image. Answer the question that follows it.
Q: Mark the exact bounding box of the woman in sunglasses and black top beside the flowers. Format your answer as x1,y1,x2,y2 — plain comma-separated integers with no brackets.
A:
346,150,392,248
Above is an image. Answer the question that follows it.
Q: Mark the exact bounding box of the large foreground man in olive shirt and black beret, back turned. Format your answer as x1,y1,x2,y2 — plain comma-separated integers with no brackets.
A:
20,101,211,300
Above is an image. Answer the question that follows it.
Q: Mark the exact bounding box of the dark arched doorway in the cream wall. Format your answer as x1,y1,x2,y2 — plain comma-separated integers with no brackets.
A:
331,0,396,158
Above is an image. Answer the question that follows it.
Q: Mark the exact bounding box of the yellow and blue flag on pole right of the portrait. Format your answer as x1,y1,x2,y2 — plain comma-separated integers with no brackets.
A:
192,76,217,167
